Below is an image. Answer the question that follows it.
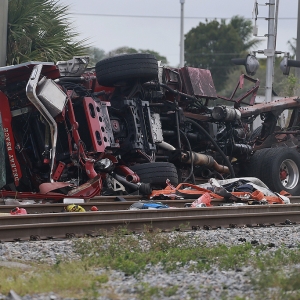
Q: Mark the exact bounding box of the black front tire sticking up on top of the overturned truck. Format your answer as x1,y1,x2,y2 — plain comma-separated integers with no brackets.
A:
95,53,158,87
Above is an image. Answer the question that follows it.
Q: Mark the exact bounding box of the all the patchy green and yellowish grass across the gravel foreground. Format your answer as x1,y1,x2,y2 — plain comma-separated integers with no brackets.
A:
0,229,300,300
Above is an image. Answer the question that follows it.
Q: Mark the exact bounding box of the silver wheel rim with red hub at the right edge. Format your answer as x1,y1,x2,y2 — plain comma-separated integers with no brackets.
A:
279,159,299,189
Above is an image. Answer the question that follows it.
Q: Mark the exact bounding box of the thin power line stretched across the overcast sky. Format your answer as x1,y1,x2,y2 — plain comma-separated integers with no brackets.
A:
69,13,297,20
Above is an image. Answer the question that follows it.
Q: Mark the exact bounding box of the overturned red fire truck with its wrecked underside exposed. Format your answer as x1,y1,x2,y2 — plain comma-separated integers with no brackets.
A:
0,54,300,201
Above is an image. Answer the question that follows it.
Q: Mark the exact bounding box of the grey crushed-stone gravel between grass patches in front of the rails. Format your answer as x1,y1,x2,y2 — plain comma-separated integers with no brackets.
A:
0,226,300,300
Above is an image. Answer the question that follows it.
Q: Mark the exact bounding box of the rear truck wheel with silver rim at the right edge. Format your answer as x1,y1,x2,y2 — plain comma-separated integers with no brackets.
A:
260,147,300,196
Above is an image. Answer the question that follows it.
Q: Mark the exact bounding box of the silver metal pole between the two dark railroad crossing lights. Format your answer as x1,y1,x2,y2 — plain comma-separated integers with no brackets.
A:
264,0,276,103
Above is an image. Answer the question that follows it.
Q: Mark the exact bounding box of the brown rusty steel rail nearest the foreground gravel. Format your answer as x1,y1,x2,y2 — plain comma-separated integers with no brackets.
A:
0,197,300,242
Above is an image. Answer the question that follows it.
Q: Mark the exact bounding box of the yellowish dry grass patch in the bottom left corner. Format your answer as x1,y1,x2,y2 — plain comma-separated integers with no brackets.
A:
0,261,108,299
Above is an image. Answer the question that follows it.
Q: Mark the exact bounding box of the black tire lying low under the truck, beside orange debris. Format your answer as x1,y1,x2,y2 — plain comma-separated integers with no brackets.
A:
130,162,178,189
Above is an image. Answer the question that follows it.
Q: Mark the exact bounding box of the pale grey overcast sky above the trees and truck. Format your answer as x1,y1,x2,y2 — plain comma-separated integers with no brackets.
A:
60,0,298,66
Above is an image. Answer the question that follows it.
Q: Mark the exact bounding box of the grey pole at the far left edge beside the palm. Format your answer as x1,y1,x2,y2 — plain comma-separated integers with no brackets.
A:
0,0,8,67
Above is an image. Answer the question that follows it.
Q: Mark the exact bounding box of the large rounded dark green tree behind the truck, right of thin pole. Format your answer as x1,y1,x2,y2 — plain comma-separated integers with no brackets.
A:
185,16,260,90
